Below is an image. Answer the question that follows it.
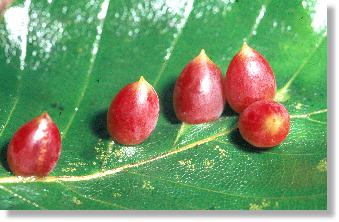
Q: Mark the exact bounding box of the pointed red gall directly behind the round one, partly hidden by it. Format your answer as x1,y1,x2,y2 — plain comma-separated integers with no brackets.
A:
225,43,276,113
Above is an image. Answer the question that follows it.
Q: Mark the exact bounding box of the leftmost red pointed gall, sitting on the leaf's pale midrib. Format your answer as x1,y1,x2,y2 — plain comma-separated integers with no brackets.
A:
7,112,61,177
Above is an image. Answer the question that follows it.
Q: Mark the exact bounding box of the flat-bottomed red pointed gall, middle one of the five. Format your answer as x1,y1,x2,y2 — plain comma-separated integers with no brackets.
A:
173,50,225,124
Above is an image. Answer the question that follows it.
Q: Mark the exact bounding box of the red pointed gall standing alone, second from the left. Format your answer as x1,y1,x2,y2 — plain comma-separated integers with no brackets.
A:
107,77,159,145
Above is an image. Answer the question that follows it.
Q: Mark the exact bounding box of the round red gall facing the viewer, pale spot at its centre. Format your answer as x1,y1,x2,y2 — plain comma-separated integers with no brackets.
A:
239,100,290,148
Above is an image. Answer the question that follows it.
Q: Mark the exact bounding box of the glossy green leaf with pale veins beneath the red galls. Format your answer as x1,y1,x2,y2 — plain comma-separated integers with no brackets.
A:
0,0,327,210
